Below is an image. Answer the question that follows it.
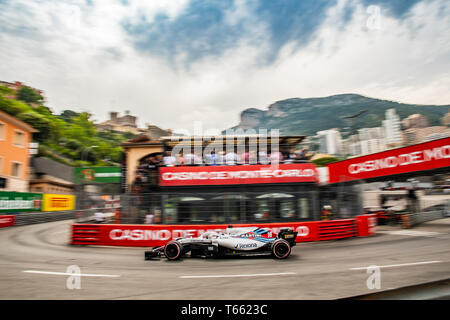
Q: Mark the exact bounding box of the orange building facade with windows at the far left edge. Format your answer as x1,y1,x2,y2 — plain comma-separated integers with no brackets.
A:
0,111,38,192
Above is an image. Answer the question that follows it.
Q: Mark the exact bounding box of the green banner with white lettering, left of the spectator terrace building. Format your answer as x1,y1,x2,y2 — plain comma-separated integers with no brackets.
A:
74,167,122,184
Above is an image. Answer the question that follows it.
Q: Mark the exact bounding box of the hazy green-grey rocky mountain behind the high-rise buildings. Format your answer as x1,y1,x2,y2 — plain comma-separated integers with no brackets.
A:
231,94,450,136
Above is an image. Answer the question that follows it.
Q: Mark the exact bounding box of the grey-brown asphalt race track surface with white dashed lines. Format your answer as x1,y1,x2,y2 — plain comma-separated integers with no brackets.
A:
0,218,450,300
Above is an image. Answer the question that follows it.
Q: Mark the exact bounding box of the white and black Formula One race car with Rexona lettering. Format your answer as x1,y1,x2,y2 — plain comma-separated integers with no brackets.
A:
145,226,297,260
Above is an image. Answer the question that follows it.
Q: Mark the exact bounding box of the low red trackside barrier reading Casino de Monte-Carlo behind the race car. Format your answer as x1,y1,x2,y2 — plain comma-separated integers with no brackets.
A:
71,214,377,247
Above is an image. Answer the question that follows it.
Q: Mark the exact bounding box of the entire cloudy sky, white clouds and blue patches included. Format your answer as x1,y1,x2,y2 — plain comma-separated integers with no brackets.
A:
0,0,450,131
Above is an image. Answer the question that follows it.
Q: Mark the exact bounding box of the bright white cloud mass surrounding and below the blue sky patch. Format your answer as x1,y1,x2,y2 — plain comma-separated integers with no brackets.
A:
0,0,450,134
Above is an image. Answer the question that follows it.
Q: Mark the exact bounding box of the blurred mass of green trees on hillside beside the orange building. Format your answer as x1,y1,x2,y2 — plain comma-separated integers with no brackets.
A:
0,87,134,166
